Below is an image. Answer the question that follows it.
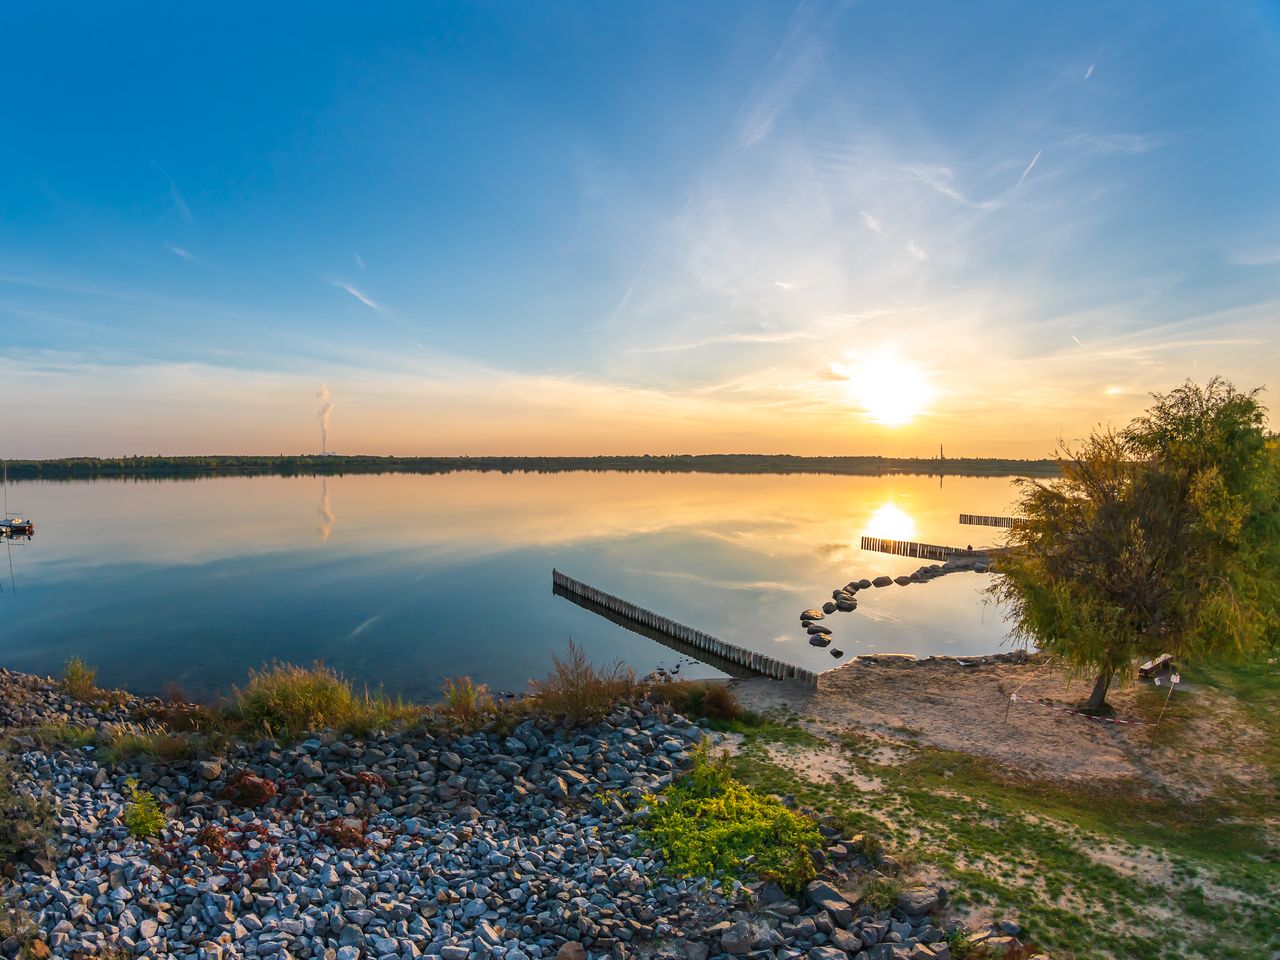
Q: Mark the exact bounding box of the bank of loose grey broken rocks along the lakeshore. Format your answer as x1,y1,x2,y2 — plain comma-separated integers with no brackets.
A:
0,672,1039,960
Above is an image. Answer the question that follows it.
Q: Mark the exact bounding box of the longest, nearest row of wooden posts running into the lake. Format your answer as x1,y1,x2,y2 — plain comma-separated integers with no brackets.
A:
552,570,818,684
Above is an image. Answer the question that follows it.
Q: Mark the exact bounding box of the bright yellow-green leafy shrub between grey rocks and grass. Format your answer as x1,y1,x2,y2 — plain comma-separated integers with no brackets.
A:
646,741,822,892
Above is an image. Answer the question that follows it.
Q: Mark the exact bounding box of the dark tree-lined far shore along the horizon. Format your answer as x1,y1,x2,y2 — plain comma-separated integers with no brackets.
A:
8,453,1059,480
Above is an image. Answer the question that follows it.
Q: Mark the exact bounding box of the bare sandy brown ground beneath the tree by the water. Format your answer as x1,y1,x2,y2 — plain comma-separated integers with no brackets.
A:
735,657,1265,795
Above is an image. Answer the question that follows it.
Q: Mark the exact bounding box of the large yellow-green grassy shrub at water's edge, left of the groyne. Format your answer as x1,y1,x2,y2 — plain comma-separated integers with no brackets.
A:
236,662,422,737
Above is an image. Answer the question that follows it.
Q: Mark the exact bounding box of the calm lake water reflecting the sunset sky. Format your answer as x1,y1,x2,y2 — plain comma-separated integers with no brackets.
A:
0,472,1012,699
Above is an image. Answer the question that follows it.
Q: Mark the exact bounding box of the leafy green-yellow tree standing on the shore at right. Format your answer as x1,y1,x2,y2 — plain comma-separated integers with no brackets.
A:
991,379,1280,710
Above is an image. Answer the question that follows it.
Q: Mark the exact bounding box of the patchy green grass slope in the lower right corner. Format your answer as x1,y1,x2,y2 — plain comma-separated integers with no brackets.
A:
733,662,1280,960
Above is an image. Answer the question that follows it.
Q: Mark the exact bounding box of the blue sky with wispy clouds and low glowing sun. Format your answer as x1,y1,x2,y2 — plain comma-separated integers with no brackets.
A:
0,0,1280,457
